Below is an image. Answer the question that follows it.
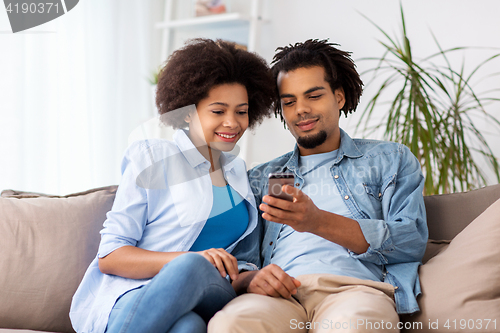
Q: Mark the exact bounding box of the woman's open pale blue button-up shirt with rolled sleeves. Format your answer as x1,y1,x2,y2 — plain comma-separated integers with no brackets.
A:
70,130,260,333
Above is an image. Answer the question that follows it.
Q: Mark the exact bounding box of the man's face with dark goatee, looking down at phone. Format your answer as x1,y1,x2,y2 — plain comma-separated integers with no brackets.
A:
277,66,345,155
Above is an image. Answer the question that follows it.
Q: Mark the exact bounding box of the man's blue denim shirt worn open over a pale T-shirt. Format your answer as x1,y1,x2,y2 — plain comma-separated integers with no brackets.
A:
248,129,428,314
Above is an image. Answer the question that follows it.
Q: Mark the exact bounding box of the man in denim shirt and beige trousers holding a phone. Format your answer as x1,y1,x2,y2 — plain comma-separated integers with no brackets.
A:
209,40,428,333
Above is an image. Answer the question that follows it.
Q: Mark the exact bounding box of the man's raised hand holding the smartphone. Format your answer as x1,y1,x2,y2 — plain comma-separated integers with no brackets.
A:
259,185,322,232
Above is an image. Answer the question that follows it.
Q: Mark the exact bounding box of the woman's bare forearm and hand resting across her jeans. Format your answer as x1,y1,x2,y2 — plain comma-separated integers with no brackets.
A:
99,246,238,280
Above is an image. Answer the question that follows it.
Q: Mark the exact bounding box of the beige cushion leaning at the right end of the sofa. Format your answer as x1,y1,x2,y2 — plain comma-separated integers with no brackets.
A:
404,199,500,332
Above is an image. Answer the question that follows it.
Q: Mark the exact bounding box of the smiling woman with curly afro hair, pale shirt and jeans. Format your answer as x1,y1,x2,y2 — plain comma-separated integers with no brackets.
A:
70,39,274,333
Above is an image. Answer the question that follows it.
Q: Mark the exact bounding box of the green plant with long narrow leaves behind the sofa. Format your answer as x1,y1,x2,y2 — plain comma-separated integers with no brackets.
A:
358,5,500,195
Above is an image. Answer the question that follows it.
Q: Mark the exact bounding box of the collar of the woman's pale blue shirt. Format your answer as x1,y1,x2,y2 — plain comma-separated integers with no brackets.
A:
173,129,236,171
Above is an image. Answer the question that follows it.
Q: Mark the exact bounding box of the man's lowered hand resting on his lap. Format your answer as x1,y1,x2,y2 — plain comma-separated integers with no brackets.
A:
247,264,300,298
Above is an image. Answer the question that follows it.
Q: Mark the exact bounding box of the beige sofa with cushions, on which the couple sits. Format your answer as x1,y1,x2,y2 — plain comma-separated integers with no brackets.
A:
0,184,500,333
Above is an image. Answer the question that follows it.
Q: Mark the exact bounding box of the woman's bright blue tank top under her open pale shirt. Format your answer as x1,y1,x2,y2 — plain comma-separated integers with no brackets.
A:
190,185,248,251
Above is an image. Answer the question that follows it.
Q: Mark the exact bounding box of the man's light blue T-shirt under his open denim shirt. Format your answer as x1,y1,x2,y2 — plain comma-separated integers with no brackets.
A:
271,150,383,281
